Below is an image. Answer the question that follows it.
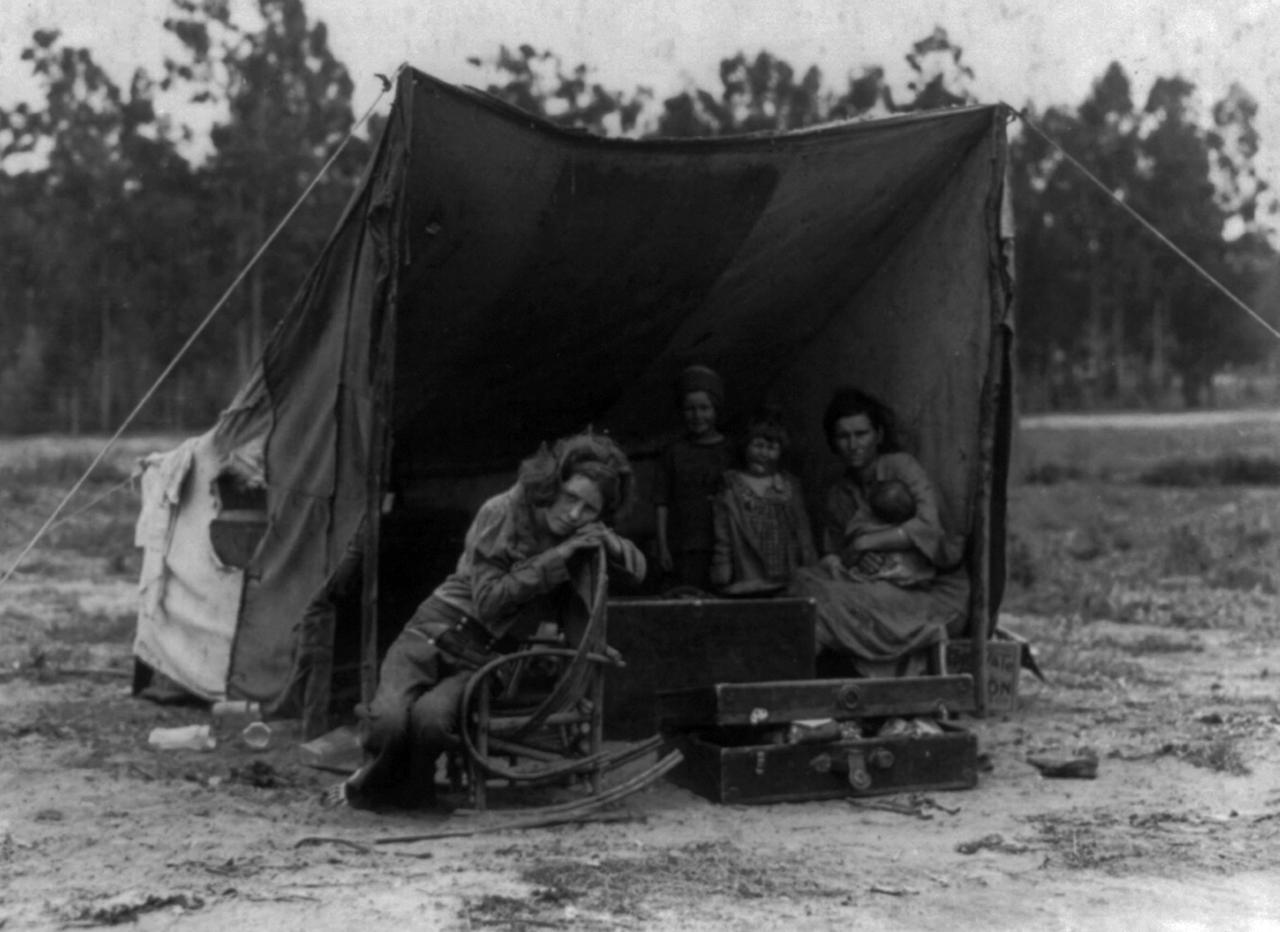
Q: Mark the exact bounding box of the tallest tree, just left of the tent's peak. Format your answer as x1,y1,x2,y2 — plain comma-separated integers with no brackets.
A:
163,0,369,378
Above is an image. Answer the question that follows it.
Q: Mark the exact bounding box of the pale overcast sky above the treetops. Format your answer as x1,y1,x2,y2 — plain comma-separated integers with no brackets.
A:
0,0,1280,186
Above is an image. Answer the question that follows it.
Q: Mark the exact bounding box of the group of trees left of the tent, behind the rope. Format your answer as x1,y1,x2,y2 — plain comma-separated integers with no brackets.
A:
0,0,371,433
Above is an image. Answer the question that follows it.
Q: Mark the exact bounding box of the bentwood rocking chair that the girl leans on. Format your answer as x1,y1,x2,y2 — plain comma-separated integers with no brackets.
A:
460,550,671,809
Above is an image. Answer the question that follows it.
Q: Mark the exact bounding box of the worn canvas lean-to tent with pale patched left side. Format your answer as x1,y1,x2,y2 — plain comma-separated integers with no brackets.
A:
137,69,1011,722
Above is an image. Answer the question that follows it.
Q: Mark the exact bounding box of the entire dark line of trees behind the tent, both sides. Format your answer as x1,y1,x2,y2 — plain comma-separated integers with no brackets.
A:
0,0,1277,433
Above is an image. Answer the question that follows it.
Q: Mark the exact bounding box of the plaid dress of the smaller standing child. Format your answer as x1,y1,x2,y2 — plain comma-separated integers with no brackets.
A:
710,470,818,594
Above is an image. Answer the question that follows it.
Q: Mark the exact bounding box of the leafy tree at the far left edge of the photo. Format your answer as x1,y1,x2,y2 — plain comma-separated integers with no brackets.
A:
0,29,187,433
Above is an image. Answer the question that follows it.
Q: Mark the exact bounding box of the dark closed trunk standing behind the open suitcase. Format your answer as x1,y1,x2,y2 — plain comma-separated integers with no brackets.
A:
604,599,814,740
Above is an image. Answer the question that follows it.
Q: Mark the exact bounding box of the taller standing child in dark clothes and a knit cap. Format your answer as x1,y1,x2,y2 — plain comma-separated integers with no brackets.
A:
654,366,731,589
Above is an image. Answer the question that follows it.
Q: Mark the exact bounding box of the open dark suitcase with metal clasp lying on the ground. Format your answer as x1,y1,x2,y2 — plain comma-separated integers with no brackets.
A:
658,675,978,803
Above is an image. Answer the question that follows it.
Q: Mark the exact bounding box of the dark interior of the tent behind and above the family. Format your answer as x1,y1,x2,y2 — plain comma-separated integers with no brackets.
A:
244,72,1011,722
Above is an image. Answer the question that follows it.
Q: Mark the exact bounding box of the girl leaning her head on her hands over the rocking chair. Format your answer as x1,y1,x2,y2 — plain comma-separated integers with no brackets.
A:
324,433,645,808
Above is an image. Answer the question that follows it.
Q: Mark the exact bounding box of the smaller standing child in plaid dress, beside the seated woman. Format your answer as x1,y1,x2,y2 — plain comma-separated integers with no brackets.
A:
710,415,818,595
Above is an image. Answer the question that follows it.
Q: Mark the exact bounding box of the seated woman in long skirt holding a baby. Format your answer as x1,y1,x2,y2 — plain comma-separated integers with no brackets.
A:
794,389,969,672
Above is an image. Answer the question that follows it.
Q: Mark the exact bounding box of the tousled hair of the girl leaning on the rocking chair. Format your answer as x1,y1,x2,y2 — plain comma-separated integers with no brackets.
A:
516,430,635,522
